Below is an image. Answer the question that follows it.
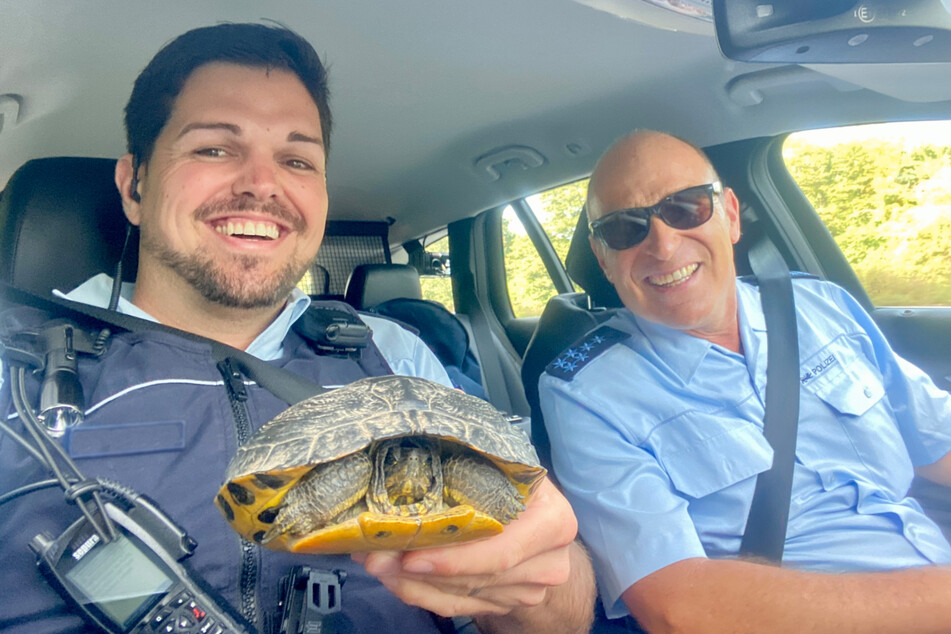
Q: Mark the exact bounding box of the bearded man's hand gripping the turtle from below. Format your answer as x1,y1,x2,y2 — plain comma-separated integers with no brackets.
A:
353,478,594,632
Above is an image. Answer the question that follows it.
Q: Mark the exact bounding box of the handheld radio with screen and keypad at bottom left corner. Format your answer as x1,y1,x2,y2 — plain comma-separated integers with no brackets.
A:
30,482,255,634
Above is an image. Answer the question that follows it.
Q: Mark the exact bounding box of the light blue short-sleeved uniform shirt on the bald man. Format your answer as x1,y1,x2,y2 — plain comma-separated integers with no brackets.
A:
539,279,951,617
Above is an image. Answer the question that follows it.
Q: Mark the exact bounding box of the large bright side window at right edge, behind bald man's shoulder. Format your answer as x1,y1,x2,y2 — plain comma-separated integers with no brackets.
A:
783,121,951,306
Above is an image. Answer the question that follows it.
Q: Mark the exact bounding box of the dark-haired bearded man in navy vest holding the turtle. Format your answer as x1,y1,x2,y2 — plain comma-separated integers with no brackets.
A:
0,24,593,633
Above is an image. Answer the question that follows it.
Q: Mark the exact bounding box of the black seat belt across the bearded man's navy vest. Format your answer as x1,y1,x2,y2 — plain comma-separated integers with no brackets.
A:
0,282,327,405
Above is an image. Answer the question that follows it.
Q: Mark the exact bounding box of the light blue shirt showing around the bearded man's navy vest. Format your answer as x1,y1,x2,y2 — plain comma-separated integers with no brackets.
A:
0,273,453,387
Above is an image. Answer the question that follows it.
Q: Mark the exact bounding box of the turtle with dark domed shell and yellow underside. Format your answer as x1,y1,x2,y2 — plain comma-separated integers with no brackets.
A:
215,375,546,554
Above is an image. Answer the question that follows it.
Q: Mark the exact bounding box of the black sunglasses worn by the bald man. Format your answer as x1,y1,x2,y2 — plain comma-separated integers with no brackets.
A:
588,181,723,251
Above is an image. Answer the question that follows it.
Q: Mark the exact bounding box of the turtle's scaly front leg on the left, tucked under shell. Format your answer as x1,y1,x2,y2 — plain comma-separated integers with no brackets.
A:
261,451,373,544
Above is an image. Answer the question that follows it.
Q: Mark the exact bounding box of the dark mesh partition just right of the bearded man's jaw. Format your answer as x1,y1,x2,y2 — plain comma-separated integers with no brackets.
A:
301,221,390,295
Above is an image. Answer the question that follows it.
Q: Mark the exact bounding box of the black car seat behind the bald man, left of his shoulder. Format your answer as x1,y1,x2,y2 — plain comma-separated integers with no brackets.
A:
522,209,621,470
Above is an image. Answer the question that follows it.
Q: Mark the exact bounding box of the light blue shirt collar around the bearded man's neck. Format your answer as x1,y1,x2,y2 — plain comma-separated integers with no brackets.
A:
53,273,310,361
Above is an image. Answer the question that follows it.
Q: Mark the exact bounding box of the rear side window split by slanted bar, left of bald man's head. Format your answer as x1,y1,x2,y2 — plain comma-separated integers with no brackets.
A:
502,179,588,317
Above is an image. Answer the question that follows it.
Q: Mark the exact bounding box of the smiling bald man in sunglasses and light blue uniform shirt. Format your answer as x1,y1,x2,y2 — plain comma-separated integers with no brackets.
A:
539,131,951,632
